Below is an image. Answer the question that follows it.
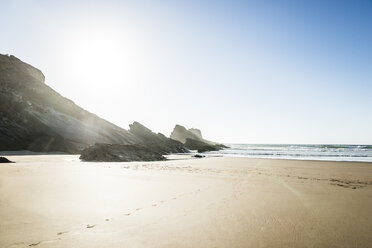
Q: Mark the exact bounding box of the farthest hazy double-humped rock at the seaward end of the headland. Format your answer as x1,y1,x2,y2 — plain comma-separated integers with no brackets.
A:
170,125,228,152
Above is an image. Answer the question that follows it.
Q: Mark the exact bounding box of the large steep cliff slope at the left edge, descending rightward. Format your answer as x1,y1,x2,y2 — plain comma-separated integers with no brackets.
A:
0,54,140,153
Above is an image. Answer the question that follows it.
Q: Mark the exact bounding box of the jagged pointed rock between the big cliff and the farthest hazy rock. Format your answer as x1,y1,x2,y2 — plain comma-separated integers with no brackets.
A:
129,121,189,154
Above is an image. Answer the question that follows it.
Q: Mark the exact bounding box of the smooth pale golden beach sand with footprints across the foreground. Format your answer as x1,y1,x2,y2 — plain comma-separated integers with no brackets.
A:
0,155,372,248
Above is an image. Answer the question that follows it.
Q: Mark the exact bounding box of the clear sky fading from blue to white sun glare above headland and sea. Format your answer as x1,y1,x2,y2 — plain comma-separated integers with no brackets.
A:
0,0,372,144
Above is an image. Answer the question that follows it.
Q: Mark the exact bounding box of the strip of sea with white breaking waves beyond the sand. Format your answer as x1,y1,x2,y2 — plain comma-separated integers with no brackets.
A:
205,144,372,162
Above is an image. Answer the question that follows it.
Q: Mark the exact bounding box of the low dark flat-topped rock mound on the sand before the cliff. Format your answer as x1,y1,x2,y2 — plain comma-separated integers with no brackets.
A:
80,144,166,162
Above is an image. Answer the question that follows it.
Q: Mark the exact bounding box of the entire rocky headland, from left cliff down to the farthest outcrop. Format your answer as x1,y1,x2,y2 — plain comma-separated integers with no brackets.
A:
0,54,221,161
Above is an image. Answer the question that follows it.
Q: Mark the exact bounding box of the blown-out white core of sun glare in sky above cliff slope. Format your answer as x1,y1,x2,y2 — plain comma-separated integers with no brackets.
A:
60,23,148,109
